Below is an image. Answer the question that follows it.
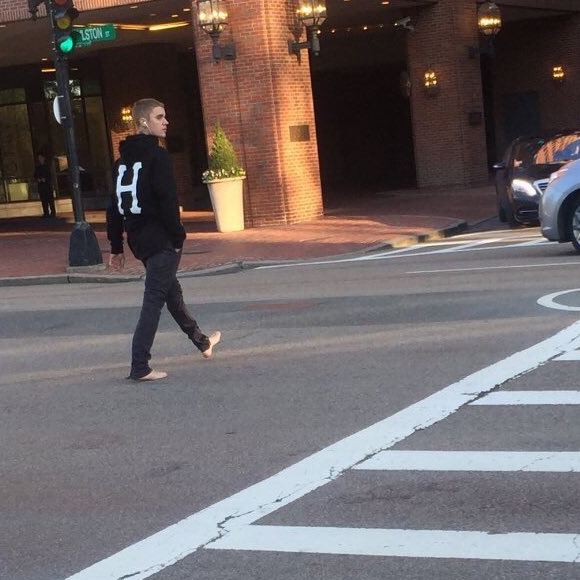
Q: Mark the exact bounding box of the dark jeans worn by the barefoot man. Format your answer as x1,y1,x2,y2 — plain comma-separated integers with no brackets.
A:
131,248,210,379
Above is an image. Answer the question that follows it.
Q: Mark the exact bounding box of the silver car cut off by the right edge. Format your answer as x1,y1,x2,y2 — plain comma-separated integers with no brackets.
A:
540,159,580,253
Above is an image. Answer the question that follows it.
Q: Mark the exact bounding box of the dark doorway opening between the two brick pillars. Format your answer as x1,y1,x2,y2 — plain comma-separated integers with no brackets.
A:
312,33,416,205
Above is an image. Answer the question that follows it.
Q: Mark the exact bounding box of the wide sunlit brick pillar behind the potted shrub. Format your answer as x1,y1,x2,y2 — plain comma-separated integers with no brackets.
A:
193,0,322,226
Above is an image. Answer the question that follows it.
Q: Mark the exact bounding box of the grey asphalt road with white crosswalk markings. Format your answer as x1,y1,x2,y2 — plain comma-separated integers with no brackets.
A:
0,224,580,580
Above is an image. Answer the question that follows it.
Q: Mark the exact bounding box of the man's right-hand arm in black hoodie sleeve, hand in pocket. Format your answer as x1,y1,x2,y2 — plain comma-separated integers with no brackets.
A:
151,148,185,249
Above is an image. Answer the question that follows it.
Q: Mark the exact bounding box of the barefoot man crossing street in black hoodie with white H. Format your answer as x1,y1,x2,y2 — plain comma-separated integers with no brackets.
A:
107,99,221,381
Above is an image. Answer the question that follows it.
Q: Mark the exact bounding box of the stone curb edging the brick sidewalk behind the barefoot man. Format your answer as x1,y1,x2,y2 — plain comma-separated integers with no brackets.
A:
0,218,466,288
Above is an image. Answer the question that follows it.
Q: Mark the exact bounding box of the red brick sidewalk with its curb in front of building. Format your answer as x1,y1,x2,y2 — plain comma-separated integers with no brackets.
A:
0,186,496,286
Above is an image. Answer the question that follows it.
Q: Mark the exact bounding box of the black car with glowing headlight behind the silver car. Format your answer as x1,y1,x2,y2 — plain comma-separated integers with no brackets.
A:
493,130,580,225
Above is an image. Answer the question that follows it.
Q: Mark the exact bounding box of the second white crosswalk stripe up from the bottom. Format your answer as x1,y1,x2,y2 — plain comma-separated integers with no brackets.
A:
354,451,580,473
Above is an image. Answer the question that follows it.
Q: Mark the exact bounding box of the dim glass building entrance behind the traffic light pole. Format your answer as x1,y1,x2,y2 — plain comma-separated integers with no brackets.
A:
0,62,111,217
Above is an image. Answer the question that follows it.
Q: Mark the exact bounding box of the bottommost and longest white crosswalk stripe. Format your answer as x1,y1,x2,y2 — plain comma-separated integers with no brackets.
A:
207,525,580,563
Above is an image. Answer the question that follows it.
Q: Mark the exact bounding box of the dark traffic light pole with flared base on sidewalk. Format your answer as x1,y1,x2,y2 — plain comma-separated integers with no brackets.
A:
46,0,103,269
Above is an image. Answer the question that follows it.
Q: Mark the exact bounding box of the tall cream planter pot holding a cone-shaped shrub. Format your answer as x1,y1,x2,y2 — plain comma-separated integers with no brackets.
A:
207,177,245,232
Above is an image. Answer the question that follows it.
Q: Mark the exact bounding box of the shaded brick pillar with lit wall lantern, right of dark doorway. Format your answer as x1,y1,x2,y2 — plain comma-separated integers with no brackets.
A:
407,0,488,187
